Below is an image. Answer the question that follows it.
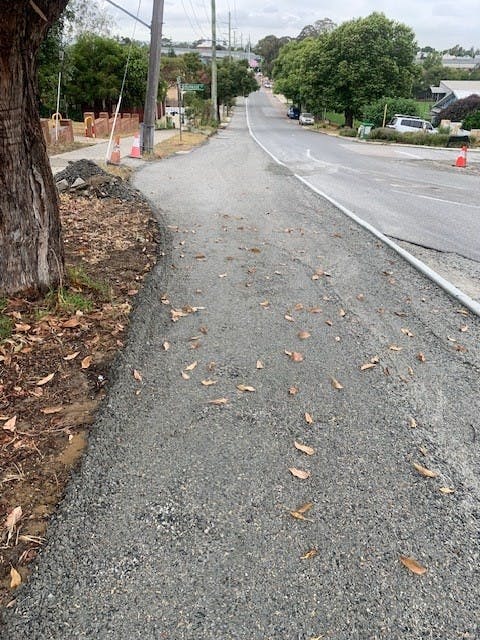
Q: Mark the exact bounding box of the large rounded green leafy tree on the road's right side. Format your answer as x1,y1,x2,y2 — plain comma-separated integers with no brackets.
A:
305,12,416,127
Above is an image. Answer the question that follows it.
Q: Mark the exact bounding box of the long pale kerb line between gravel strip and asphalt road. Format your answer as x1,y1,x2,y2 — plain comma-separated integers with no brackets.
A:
245,98,480,317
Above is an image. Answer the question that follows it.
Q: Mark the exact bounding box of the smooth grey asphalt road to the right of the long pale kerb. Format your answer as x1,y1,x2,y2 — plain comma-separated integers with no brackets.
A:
248,90,480,263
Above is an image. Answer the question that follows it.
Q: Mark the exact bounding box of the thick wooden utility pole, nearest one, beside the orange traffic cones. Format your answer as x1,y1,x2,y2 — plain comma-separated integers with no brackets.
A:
142,0,163,153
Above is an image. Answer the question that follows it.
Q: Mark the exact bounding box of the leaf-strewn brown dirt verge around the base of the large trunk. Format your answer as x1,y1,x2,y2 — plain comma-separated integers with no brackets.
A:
0,163,158,606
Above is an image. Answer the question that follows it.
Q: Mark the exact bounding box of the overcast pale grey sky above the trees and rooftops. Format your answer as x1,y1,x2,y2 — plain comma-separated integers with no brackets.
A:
104,0,480,50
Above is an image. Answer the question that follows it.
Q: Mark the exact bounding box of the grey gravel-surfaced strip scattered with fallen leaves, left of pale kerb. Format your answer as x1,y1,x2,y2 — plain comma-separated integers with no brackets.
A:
1,97,480,640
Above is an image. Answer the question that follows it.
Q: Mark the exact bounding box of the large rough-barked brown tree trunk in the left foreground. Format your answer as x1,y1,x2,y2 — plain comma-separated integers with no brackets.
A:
0,0,68,295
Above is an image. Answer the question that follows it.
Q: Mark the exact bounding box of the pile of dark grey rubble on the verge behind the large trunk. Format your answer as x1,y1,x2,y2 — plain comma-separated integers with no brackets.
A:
55,160,144,201
